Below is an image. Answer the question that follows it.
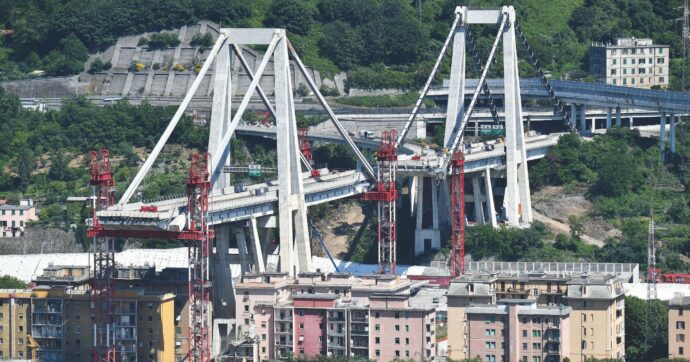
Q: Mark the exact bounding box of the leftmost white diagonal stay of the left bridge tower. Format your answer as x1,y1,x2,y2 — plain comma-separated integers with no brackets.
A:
117,33,228,205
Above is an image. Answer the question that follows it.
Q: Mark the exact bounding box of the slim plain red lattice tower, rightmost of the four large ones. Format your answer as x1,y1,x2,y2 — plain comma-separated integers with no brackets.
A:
450,150,465,278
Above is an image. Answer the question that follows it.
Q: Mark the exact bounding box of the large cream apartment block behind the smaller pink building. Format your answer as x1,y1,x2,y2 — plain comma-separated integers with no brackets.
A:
447,271,625,361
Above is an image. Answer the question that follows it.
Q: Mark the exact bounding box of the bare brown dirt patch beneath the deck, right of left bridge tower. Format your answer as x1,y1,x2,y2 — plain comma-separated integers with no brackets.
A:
315,203,364,258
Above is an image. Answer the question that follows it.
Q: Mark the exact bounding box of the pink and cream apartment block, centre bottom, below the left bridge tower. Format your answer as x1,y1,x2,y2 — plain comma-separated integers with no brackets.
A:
235,273,436,361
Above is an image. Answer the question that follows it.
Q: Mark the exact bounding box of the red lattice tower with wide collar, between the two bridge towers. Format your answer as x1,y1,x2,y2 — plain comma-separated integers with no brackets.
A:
362,130,398,274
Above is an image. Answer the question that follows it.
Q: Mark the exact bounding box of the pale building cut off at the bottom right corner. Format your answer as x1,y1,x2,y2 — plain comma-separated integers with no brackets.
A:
668,296,690,359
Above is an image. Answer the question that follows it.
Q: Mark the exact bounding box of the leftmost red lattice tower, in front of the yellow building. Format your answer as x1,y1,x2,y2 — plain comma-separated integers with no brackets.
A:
87,148,116,362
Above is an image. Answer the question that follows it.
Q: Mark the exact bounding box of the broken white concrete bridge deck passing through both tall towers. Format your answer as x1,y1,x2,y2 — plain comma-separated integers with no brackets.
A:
92,132,560,231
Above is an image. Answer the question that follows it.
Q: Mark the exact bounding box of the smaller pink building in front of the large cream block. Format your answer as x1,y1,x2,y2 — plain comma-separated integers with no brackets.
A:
465,299,572,362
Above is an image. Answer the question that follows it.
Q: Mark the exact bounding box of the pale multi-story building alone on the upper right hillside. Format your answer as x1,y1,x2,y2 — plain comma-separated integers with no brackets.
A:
589,38,670,88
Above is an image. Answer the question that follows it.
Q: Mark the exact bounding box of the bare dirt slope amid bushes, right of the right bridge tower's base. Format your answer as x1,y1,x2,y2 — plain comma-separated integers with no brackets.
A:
532,186,620,246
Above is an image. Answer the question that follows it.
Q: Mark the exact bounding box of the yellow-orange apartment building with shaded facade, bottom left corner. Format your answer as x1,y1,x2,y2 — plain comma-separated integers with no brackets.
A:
0,286,175,361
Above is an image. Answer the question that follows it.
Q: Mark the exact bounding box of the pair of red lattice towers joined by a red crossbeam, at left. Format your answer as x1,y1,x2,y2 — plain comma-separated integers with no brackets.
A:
87,150,215,362
